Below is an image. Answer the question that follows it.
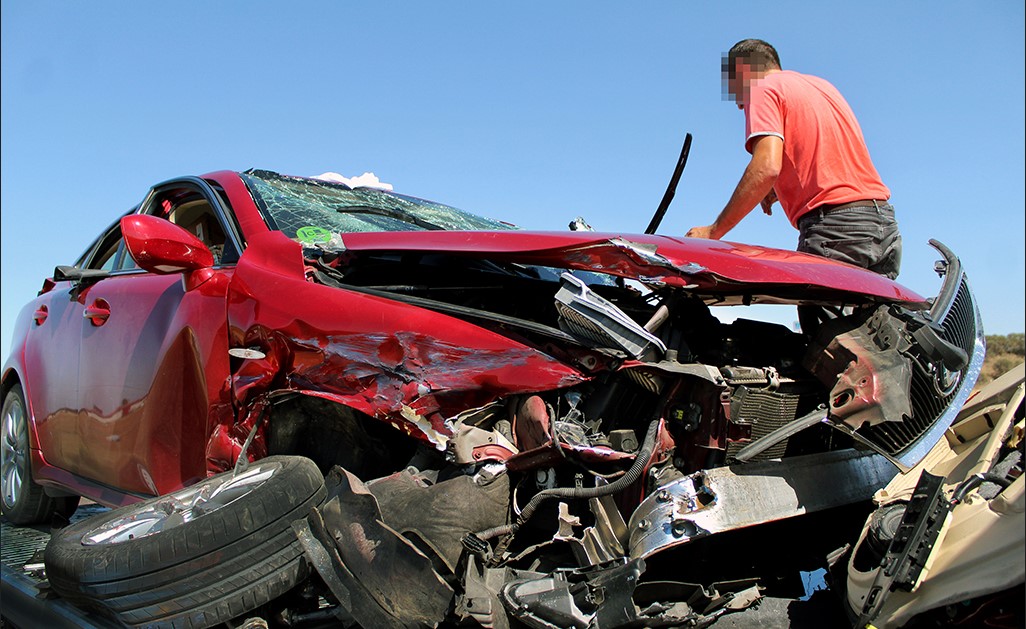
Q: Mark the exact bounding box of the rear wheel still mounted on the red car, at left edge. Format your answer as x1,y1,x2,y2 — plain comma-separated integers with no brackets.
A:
0,385,78,525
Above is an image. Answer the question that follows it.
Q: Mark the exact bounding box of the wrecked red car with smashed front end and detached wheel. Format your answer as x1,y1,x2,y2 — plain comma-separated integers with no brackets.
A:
0,170,984,627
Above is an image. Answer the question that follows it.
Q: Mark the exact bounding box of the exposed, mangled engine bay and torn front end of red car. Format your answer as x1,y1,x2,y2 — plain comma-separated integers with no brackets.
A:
255,238,982,627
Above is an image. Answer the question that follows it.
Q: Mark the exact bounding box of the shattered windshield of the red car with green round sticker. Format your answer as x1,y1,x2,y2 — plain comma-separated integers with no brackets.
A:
241,170,516,244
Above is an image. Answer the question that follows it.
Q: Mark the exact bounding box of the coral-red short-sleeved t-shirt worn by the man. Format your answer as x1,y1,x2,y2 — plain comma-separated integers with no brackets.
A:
745,70,891,227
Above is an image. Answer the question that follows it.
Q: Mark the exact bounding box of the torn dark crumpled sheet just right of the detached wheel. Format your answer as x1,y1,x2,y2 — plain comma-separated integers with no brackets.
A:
297,467,453,628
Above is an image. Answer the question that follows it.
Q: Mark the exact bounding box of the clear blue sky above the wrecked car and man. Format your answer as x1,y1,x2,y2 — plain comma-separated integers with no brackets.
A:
0,0,1026,357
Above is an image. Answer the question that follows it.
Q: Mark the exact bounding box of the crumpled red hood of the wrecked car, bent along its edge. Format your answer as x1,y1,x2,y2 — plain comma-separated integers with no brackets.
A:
332,231,928,308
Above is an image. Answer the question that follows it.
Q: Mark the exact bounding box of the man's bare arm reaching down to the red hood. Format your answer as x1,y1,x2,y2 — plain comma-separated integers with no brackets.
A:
686,135,784,240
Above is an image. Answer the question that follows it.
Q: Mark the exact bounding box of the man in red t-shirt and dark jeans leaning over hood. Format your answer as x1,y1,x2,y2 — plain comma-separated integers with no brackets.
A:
686,39,901,279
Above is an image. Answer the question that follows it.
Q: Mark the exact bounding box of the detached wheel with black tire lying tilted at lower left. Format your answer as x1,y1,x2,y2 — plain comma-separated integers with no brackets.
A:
44,457,325,627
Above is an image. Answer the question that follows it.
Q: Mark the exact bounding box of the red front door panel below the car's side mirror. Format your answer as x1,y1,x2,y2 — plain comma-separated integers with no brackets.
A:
74,269,231,495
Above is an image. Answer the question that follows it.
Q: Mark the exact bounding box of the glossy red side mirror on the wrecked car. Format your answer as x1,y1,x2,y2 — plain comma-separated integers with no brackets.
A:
121,214,213,274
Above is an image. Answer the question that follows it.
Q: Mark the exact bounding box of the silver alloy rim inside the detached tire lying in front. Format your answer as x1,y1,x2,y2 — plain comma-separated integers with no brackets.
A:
82,462,281,546
